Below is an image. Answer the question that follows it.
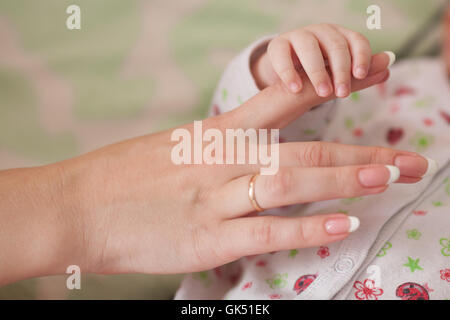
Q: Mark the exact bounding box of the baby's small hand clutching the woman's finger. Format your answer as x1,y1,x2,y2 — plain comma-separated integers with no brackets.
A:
252,24,394,97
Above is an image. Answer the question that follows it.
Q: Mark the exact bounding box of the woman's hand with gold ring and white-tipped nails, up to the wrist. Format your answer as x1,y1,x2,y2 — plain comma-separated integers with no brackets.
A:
54,54,427,273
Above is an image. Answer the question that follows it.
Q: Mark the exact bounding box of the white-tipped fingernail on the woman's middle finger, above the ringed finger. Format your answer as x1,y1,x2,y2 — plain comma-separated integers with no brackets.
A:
394,155,437,178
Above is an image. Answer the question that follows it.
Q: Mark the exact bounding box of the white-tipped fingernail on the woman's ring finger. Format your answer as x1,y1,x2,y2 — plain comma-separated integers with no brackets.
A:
358,166,400,187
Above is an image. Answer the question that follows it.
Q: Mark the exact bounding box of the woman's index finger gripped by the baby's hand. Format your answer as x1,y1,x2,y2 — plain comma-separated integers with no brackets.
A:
228,52,393,129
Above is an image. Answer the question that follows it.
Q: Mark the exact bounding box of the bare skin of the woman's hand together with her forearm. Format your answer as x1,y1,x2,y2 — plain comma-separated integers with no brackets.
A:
0,24,427,284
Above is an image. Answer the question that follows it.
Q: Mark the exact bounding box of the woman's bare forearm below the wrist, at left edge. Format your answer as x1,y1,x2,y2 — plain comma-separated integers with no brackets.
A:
0,165,85,285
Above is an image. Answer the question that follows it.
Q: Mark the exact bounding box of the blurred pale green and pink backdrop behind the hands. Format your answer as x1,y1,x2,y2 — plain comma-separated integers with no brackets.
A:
0,0,445,299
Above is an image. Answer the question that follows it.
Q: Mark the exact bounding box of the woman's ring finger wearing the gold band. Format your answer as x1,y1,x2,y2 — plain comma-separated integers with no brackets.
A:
217,165,400,217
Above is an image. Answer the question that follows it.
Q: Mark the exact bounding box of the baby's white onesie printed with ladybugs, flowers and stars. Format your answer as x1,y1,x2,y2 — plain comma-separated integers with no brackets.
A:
176,38,450,300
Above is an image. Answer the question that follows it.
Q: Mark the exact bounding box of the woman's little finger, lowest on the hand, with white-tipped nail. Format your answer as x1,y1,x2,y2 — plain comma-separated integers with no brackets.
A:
218,213,359,260
